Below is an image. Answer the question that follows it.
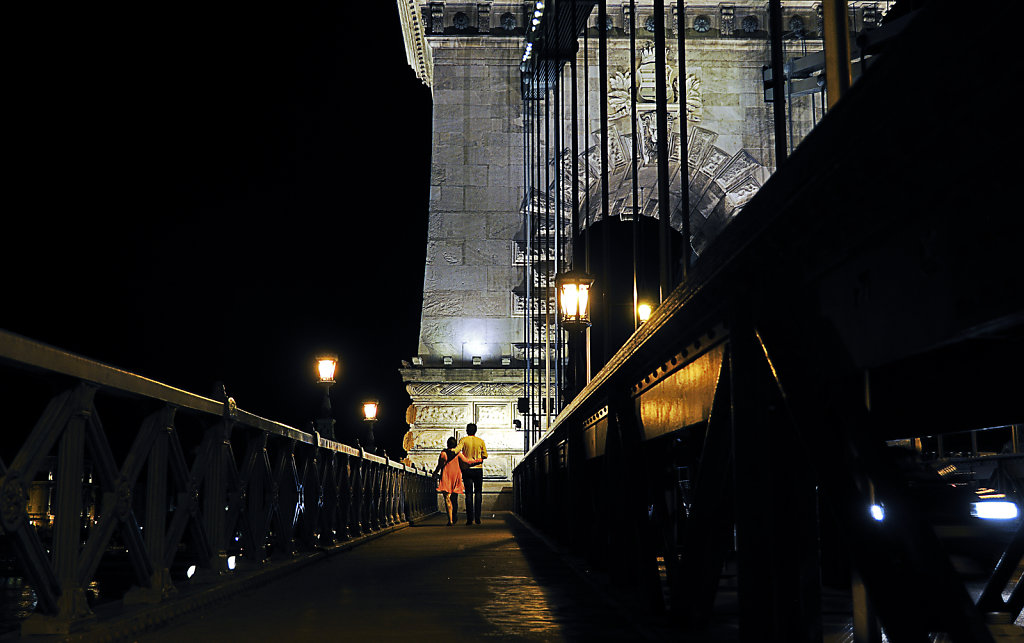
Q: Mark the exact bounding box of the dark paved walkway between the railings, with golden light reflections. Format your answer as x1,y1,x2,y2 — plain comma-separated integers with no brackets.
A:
135,514,655,643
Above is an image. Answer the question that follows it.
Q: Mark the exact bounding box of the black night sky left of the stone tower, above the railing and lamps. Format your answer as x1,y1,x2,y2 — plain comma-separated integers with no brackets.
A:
0,0,431,454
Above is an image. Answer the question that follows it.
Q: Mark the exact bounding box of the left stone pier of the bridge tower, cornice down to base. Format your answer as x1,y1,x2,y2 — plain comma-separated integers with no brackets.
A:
398,0,525,508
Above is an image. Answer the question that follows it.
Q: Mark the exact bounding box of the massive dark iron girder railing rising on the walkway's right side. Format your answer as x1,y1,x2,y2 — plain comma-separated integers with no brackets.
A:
514,3,1024,642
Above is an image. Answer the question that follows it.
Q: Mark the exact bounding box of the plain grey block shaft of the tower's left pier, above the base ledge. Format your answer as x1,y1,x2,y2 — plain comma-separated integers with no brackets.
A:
419,38,523,366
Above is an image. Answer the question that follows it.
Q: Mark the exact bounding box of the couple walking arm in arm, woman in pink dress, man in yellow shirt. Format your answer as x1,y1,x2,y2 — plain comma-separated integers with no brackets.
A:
434,422,487,525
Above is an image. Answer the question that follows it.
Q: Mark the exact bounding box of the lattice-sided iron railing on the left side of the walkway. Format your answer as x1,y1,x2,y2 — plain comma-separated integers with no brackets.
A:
0,330,437,634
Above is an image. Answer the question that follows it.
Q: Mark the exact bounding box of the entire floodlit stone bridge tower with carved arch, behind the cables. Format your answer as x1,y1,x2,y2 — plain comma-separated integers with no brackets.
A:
397,0,890,508
